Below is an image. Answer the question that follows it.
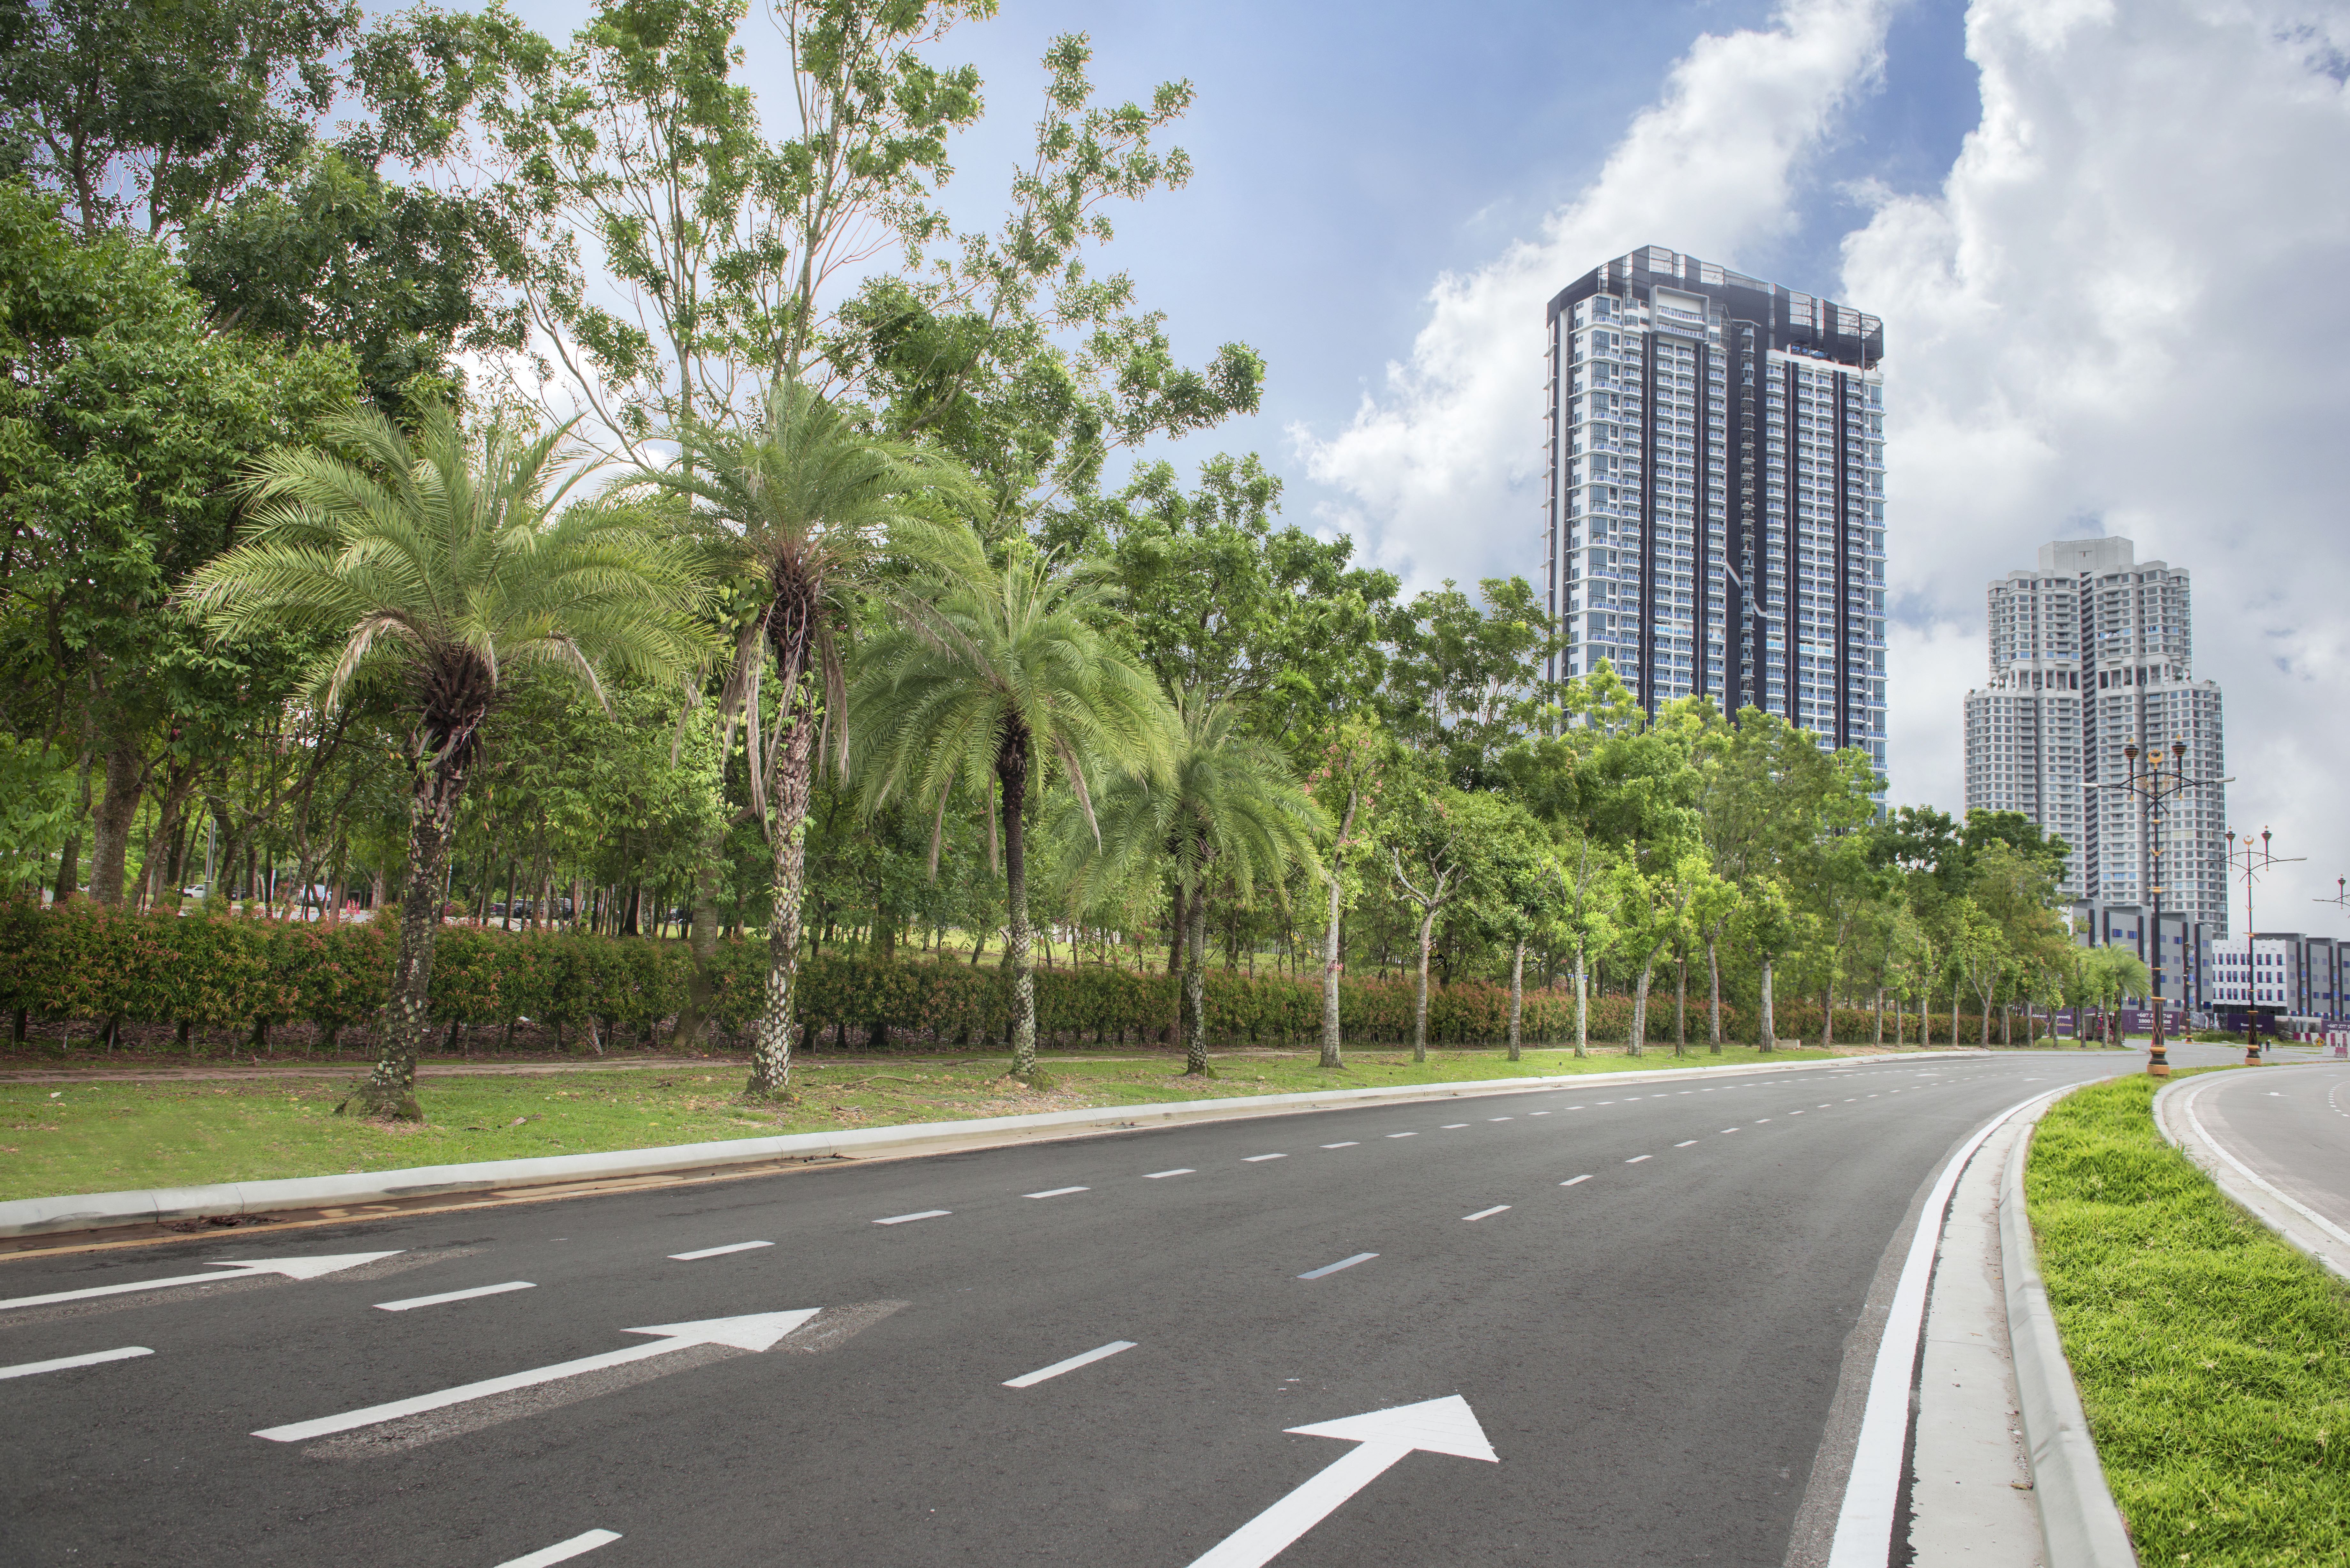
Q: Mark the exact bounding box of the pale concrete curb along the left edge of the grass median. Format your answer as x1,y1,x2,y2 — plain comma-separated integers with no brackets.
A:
2000,1091,2139,1568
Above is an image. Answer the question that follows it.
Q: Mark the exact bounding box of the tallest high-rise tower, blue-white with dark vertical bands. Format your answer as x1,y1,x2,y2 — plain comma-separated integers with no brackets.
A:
1544,245,1885,773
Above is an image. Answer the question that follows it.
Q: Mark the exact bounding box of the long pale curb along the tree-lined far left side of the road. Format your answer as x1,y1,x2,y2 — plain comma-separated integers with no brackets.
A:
0,1048,1986,1237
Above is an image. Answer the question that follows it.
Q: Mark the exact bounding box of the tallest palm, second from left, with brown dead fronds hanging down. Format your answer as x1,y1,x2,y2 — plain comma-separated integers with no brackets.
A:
651,381,973,1098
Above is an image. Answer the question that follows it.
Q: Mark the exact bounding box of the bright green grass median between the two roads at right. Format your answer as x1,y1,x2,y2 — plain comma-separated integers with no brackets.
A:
2026,1070,2350,1568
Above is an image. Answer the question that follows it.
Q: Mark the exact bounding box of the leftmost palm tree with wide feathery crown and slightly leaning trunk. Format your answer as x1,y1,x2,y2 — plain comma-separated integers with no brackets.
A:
188,409,707,1119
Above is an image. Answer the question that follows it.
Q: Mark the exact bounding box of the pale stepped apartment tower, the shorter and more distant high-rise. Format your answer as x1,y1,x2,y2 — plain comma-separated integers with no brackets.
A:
1967,538,2228,936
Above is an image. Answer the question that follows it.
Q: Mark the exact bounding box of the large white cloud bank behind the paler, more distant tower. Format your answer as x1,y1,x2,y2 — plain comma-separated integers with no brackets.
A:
1845,0,2350,912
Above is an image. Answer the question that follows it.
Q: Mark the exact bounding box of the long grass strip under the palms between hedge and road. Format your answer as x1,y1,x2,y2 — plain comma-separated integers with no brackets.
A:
0,1046,1852,1199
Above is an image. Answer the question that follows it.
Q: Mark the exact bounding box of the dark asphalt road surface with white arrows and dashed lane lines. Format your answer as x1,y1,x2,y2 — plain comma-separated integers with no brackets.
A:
0,1051,2134,1568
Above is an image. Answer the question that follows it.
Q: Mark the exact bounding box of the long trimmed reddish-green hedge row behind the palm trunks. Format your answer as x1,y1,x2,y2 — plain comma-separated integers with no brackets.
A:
0,903,1972,1046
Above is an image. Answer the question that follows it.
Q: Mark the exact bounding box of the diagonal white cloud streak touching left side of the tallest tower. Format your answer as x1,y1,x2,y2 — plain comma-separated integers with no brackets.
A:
1290,0,1887,585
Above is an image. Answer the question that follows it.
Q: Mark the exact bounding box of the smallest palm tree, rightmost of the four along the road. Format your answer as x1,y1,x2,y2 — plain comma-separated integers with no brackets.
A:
1072,693,1330,1074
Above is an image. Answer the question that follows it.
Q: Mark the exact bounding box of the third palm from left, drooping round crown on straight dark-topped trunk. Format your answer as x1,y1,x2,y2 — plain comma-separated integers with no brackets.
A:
848,550,1170,1077
